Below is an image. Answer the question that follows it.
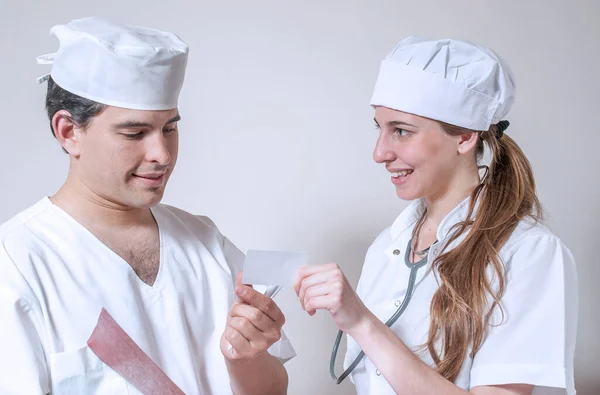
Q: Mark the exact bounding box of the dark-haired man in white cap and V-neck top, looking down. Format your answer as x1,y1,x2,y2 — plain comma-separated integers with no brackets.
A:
0,18,295,395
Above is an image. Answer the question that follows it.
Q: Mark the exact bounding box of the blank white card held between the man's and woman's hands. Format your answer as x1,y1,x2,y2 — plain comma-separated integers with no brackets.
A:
242,250,308,286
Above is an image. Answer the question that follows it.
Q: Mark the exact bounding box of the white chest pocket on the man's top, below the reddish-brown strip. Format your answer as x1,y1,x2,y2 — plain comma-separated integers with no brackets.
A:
50,346,131,395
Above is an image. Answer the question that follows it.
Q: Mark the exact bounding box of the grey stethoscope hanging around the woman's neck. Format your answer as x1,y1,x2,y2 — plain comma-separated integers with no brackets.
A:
329,238,437,384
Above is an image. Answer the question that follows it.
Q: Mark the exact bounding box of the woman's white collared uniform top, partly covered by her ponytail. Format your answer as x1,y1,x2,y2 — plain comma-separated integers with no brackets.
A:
344,199,577,395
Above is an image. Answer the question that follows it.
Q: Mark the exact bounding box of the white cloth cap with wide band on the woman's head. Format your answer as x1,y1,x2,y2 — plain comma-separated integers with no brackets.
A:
371,37,515,130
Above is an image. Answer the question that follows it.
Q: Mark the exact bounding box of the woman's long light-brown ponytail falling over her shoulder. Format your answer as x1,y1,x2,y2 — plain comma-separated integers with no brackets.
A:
424,123,543,382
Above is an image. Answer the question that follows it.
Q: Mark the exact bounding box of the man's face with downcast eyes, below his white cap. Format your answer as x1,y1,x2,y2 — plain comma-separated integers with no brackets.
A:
71,106,179,208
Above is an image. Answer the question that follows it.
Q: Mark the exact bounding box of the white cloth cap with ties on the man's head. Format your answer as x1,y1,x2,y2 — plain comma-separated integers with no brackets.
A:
38,18,188,110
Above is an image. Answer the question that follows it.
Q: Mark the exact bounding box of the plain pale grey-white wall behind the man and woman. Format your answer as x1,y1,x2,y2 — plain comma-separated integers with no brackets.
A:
0,0,600,395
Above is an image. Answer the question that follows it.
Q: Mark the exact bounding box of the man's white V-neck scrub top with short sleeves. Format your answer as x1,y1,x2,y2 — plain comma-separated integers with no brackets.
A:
0,198,295,395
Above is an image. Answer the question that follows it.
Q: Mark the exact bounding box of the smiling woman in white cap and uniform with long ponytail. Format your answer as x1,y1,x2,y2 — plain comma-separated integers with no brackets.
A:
295,37,577,395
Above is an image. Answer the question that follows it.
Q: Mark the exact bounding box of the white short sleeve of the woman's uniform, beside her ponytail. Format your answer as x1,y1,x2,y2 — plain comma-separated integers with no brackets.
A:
470,235,578,395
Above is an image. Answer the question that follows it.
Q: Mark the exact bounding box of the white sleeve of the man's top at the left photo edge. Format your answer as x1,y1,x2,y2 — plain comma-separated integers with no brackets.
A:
0,245,50,394
